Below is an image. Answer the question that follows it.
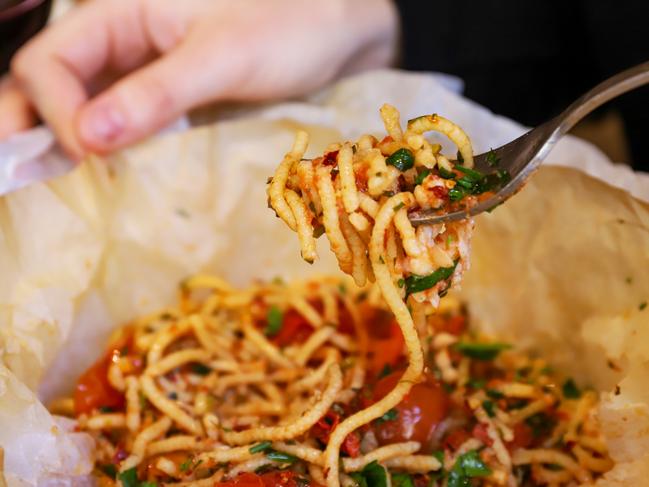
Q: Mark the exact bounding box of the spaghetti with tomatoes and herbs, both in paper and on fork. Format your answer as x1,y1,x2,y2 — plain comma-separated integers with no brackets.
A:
52,105,612,487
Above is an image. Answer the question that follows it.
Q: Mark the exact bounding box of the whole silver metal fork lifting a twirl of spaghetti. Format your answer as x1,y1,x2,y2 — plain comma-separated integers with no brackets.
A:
409,61,649,225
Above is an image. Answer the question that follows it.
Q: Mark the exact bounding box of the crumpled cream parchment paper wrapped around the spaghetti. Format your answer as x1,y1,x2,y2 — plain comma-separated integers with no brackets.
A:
0,71,649,486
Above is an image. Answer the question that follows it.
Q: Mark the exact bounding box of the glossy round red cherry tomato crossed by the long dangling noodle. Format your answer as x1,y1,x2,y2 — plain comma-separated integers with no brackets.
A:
373,371,449,444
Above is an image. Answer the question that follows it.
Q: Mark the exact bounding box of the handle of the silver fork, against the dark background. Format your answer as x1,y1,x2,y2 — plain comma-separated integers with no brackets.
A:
554,61,649,136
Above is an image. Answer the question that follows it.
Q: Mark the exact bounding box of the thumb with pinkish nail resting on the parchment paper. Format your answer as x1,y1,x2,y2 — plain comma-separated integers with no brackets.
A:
76,46,218,153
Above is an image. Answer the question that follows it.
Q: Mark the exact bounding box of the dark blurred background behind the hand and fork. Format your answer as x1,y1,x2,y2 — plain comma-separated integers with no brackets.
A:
0,0,649,170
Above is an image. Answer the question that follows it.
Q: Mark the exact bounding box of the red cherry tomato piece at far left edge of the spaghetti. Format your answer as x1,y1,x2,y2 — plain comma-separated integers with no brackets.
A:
74,328,133,416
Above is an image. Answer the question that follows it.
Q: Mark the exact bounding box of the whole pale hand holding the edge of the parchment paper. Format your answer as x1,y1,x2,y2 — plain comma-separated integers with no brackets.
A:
0,0,397,159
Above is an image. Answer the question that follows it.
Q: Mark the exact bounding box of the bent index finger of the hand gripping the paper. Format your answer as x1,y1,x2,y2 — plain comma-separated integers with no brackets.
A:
12,0,158,158
